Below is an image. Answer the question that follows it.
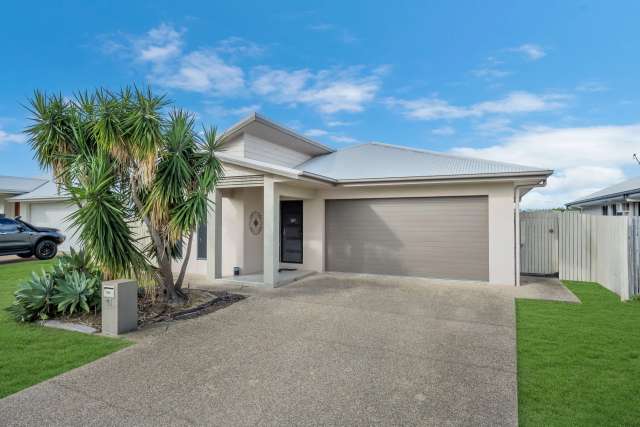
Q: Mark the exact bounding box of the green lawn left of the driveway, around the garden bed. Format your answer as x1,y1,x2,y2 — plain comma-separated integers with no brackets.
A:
0,261,130,398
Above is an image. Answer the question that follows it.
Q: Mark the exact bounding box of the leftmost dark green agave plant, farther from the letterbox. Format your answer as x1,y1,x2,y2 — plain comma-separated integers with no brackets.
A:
7,271,55,322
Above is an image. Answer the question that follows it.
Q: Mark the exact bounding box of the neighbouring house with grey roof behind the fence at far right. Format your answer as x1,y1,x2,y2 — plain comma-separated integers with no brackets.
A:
566,177,640,216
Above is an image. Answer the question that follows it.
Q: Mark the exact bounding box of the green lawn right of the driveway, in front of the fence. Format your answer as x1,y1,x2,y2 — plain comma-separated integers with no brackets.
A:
516,282,640,426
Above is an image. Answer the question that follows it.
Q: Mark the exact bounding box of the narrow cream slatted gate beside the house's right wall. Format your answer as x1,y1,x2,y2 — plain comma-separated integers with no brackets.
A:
520,211,560,274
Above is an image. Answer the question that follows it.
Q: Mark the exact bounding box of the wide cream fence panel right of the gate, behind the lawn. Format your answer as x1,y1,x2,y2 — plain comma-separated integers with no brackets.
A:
559,212,630,300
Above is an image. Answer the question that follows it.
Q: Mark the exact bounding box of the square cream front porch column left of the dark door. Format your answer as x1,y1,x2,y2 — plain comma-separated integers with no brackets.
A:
262,176,280,286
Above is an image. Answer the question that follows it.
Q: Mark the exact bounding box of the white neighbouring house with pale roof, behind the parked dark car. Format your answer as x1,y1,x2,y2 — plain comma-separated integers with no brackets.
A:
6,180,80,251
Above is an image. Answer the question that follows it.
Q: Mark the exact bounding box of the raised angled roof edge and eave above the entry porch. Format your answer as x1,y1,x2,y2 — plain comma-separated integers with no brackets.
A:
220,112,335,156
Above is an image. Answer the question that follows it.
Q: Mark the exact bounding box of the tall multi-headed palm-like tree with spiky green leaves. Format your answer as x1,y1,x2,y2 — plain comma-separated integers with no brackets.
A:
26,88,222,302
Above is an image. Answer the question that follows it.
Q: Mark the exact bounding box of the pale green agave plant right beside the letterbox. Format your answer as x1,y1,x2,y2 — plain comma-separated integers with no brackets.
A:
51,271,99,314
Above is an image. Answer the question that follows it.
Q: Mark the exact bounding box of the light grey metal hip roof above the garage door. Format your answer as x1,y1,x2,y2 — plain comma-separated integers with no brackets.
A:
296,142,553,181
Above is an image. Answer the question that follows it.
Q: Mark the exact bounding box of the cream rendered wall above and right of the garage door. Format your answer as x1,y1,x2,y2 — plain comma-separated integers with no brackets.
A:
316,182,516,285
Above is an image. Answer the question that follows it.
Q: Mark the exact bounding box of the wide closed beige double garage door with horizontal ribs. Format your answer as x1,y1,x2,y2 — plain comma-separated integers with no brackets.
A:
326,197,489,280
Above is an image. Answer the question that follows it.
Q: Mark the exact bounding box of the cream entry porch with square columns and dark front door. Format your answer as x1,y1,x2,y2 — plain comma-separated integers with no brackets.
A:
207,176,324,287
